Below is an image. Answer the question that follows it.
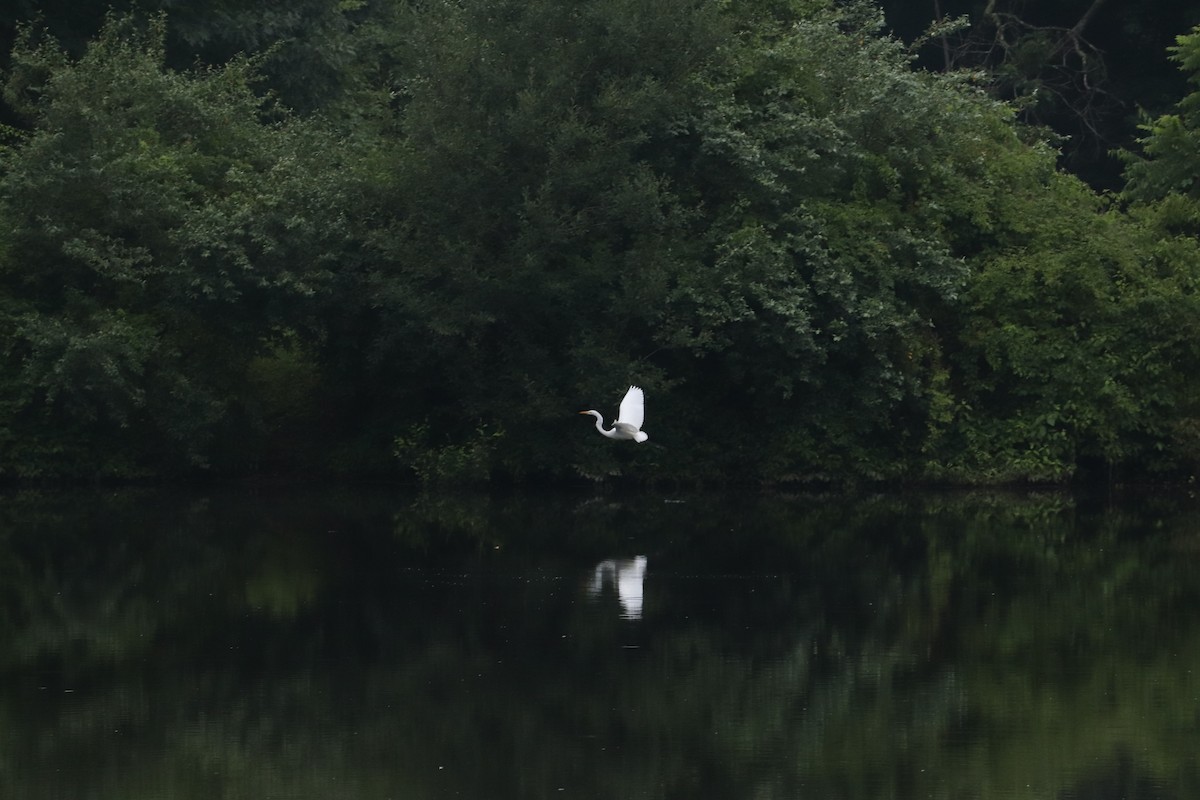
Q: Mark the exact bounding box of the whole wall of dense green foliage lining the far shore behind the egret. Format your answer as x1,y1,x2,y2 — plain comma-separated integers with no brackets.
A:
0,0,1200,481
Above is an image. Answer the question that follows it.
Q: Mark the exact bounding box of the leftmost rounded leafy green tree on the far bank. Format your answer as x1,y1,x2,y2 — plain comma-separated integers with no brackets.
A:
0,20,352,475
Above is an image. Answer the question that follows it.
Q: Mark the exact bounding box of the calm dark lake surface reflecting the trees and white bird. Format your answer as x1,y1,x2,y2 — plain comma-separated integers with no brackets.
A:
0,489,1200,800
